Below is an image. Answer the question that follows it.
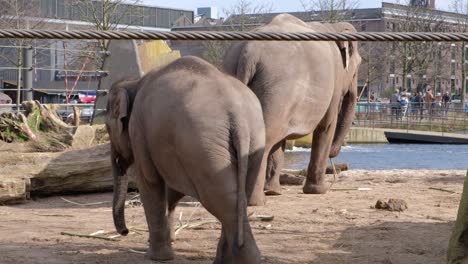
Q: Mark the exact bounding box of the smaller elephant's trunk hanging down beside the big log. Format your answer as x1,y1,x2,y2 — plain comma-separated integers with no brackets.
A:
111,150,128,236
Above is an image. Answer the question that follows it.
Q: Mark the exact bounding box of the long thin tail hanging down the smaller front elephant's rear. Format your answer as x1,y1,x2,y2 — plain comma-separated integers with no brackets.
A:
232,121,250,247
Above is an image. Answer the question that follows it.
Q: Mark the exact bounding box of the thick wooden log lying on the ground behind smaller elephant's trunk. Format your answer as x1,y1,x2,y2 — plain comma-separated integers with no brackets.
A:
0,144,136,204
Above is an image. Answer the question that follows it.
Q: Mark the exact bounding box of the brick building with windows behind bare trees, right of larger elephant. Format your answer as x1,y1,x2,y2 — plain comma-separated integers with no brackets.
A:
172,0,468,96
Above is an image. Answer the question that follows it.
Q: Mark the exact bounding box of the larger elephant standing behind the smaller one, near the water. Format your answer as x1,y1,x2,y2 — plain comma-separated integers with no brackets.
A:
223,14,361,205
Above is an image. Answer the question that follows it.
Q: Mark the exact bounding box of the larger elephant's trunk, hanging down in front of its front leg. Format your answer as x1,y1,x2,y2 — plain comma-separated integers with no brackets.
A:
330,79,357,158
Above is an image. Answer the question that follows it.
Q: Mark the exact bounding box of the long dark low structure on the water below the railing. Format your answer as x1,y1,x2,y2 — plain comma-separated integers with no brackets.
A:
384,131,468,145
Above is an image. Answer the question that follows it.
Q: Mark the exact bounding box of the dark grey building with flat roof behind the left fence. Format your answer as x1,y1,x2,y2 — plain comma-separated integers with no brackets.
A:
0,0,194,102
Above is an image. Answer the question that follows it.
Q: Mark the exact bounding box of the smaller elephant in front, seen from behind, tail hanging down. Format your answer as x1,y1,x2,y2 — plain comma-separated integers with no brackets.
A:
106,57,265,264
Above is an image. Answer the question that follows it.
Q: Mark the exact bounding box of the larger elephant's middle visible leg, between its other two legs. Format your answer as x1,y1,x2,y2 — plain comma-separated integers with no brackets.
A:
265,140,286,195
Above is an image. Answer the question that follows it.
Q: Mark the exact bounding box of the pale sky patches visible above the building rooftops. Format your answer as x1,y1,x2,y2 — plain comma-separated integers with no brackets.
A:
143,0,451,16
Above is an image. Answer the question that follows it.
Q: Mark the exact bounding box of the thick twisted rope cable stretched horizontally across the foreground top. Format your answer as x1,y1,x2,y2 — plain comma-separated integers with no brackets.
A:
0,29,468,42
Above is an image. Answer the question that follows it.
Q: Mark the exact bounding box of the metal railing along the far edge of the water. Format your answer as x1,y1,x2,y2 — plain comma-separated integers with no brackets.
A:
353,102,468,134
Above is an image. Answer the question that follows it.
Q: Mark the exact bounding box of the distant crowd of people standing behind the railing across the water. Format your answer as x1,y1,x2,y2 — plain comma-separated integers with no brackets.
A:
390,86,451,120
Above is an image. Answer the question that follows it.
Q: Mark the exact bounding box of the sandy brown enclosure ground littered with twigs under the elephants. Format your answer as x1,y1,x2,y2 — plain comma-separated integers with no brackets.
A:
0,170,465,264
